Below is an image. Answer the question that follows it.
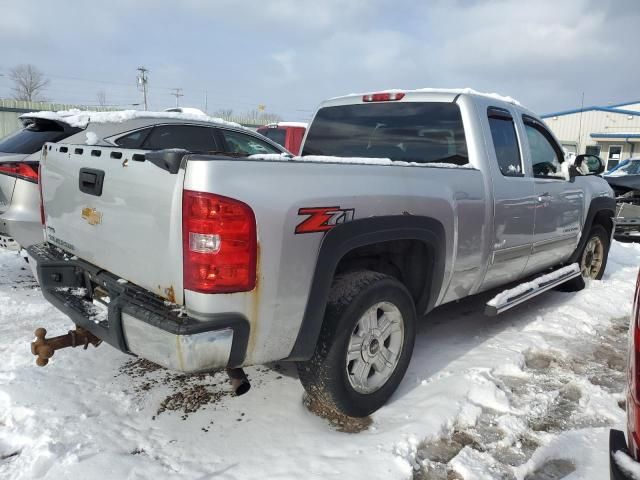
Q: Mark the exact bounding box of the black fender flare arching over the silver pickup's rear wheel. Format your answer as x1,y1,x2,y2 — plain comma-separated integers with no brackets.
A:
286,215,446,361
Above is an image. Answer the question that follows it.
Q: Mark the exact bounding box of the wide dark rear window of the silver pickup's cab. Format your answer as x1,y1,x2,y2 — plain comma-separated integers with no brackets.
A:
302,102,469,165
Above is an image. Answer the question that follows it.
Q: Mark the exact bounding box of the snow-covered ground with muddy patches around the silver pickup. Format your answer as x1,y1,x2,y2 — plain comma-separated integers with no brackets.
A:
0,242,640,480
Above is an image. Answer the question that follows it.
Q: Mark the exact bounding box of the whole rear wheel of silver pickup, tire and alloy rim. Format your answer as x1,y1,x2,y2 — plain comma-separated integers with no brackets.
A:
298,271,416,417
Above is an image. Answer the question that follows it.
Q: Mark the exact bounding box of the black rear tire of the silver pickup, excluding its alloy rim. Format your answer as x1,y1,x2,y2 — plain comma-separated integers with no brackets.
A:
297,270,416,417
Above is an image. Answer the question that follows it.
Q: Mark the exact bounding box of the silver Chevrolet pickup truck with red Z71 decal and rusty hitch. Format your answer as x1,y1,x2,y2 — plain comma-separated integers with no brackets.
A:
28,90,615,416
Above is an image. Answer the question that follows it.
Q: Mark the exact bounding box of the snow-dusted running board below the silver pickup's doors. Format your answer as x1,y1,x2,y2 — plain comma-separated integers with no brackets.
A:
484,263,580,317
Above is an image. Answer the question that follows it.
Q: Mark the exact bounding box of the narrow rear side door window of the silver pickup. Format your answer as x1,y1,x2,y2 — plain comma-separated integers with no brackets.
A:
488,107,524,177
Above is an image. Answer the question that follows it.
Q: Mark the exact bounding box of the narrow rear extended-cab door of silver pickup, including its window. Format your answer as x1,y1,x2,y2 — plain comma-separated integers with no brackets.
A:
482,106,535,290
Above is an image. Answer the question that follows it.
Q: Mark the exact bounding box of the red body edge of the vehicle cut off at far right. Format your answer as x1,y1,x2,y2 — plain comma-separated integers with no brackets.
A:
627,272,640,460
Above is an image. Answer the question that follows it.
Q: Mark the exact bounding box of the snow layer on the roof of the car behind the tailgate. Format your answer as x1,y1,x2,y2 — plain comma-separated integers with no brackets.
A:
20,109,244,128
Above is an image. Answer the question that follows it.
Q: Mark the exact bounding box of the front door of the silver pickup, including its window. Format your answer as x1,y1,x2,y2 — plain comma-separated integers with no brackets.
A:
522,115,584,273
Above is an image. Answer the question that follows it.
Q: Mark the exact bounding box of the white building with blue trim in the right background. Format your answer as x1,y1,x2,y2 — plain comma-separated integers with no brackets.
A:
542,100,640,170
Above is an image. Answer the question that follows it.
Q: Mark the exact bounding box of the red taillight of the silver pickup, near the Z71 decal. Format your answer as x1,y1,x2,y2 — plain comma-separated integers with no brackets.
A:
182,190,257,293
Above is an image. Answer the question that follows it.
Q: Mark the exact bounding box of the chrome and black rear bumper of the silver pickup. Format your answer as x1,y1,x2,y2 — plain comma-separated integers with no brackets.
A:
27,244,249,372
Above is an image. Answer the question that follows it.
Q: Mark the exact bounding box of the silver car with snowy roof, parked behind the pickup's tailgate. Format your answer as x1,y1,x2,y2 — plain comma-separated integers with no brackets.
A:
0,109,285,250
